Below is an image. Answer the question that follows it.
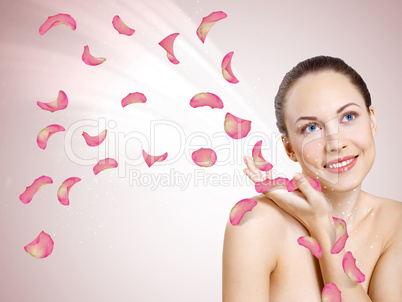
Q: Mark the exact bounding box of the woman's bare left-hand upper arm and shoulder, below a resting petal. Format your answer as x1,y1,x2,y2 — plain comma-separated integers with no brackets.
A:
222,197,281,302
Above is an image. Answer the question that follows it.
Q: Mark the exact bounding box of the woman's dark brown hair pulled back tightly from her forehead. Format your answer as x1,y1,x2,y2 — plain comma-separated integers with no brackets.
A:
275,56,371,137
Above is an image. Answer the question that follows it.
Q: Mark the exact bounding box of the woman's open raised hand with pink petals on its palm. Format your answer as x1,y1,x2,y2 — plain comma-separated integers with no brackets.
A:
243,156,335,237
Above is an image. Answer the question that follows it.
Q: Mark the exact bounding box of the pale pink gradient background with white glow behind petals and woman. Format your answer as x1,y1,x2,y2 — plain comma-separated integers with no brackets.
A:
0,0,402,302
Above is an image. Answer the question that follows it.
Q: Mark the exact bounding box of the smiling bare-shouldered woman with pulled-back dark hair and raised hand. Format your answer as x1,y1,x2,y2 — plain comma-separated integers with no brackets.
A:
223,56,402,302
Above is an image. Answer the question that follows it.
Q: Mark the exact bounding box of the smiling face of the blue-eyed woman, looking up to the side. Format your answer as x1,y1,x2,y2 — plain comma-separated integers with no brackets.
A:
283,71,377,192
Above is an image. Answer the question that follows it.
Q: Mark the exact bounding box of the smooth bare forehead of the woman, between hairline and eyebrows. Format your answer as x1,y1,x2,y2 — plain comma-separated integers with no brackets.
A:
285,71,365,125
